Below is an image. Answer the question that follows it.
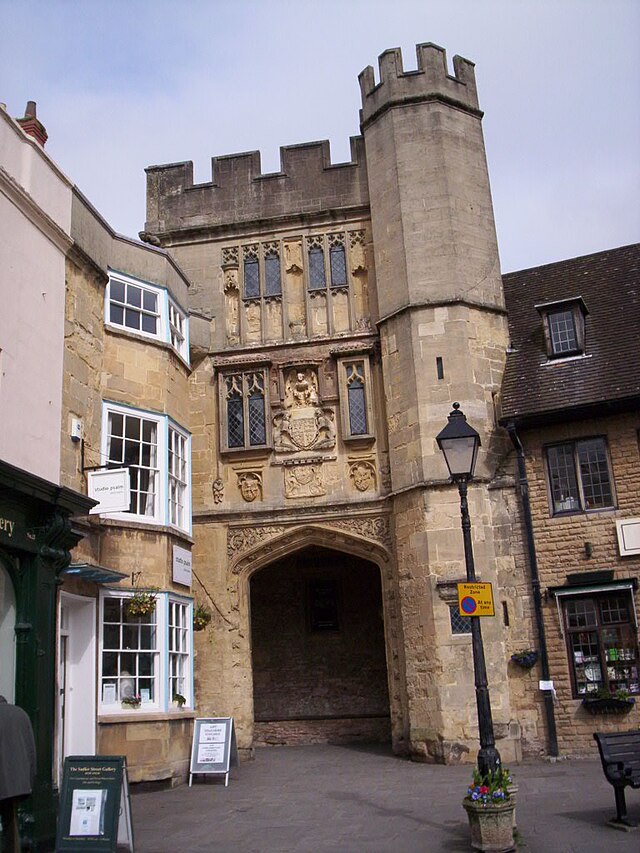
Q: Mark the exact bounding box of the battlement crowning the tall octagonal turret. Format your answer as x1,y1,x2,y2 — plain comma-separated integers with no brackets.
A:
358,42,481,129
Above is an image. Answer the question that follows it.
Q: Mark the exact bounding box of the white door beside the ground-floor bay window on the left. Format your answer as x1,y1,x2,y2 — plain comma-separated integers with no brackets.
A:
56,592,96,781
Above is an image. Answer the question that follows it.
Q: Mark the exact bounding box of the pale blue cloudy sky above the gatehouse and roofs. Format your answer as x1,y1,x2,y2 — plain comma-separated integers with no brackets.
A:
0,0,640,272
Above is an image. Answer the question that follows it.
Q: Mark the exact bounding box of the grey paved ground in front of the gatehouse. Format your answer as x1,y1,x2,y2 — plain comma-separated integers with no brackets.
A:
132,745,640,853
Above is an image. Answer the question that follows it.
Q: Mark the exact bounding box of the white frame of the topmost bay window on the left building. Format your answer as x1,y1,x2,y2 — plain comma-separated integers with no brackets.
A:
104,269,189,364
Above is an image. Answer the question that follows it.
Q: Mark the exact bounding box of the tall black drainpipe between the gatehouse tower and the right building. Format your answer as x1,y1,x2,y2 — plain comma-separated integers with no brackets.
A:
507,421,559,757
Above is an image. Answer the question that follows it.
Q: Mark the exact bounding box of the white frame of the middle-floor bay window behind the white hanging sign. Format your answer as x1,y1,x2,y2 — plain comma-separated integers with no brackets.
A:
101,400,191,534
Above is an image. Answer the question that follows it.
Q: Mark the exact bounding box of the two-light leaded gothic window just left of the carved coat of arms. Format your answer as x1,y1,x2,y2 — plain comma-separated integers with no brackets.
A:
222,370,267,450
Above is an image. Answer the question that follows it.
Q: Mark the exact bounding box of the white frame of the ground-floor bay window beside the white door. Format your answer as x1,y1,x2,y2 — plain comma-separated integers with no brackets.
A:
98,589,193,716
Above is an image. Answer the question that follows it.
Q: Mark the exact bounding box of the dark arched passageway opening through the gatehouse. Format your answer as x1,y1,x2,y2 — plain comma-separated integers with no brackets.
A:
251,547,390,744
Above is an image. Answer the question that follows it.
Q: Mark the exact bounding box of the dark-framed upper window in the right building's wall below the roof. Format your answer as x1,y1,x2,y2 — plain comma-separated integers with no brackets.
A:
546,438,614,515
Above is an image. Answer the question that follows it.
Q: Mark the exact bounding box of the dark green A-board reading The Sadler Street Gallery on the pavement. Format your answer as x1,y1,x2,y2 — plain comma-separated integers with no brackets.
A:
56,755,134,853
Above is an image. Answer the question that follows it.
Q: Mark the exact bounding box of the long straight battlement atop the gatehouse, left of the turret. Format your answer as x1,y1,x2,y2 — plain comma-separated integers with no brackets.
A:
145,136,369,236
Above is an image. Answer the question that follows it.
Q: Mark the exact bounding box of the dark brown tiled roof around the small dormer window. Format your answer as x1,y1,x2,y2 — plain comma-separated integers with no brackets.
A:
502,244,640,422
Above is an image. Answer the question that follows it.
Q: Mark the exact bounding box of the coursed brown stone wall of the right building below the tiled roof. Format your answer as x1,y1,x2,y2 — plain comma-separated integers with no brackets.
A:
521,414,640,755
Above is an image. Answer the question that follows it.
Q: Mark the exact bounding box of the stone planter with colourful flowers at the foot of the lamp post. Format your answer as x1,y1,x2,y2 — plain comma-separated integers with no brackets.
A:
462,767,516,853
